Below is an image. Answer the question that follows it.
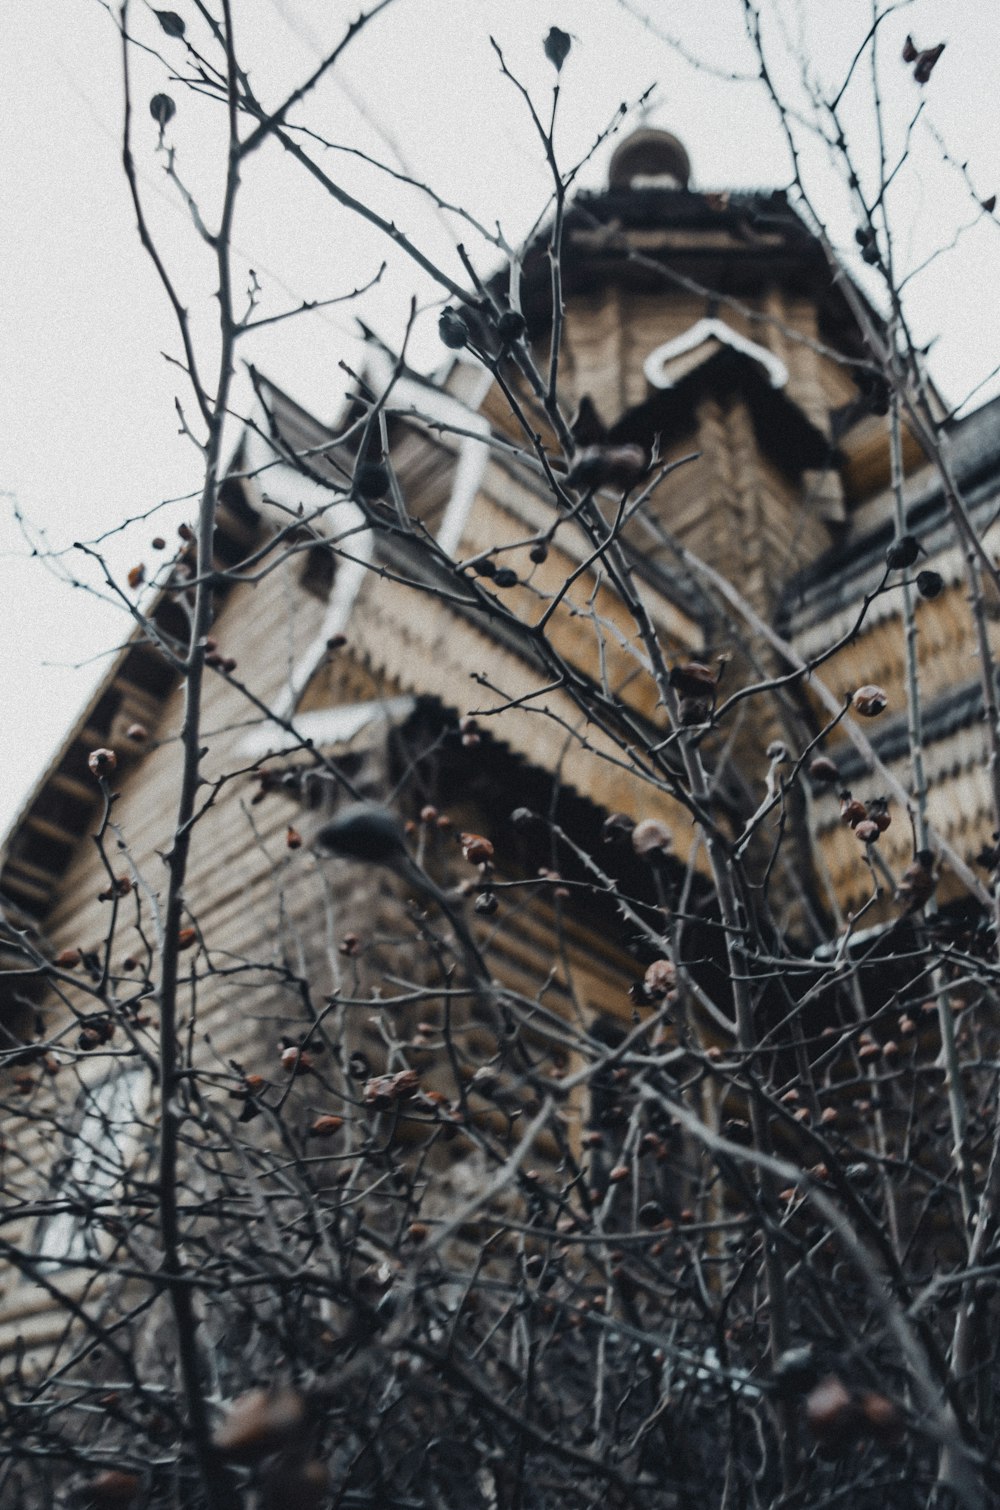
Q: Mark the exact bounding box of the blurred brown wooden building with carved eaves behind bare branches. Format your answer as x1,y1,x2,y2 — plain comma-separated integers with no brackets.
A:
0,130,1000,1401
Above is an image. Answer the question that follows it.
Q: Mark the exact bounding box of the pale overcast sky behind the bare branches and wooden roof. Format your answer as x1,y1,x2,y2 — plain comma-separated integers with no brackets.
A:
0,0,1000,832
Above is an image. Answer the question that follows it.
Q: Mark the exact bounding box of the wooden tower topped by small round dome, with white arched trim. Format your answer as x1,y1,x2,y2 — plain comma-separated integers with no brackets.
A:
510,127,894,613
